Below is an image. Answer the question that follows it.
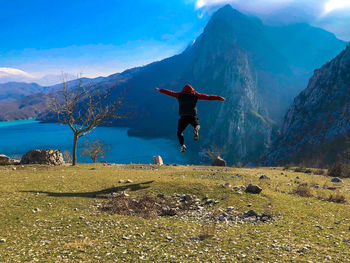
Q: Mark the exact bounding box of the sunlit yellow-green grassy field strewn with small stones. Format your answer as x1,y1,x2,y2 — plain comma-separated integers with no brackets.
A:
0,164,350,262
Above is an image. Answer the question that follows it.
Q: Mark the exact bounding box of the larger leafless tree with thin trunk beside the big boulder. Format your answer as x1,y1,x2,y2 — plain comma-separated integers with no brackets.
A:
49,75,126,165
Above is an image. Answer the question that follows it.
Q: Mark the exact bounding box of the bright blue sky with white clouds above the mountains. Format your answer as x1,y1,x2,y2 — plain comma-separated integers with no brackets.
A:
0,0,350,77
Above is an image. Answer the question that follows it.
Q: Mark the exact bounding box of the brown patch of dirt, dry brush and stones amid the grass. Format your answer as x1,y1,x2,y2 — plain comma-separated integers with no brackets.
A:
99,192,274,224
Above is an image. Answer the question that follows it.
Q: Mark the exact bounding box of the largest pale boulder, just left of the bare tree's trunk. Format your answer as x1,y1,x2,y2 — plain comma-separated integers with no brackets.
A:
21,149,64,165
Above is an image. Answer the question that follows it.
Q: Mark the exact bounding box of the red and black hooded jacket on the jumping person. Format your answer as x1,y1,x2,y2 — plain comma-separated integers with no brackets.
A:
159,85,225,117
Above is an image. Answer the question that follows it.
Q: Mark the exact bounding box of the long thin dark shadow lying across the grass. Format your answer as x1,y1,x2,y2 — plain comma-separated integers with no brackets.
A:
20,181,153,199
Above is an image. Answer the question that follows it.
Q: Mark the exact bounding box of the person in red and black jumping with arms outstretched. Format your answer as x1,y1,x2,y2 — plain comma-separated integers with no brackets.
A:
157,84,225,153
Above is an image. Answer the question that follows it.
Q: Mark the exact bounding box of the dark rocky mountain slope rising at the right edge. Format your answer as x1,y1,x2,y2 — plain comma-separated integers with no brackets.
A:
267,45,350,166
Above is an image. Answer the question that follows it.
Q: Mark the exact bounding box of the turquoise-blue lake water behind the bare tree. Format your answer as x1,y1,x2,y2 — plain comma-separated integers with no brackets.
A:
0,120,189,164
